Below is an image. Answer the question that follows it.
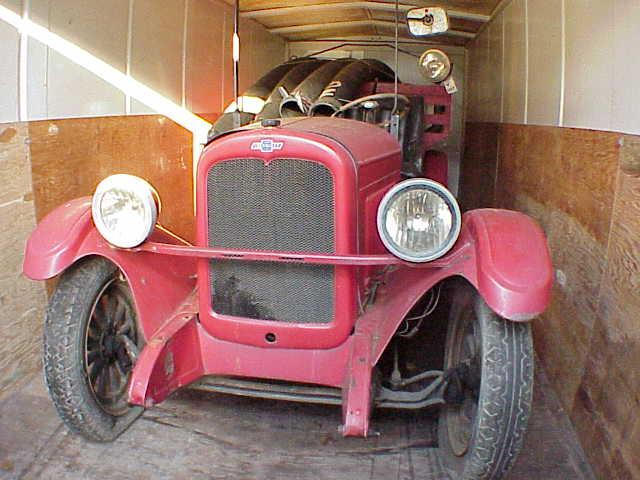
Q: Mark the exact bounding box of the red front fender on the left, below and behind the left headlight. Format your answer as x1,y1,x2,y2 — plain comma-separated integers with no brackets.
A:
23,197,196,339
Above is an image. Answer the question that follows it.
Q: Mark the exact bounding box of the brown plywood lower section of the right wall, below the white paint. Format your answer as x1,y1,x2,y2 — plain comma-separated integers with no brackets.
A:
462,123,640,479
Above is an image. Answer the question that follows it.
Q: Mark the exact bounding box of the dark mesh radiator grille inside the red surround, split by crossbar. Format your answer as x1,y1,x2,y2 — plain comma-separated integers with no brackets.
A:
207,159,334,323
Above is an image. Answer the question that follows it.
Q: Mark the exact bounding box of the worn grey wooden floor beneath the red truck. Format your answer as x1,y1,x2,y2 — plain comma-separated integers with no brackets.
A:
0,366,593,480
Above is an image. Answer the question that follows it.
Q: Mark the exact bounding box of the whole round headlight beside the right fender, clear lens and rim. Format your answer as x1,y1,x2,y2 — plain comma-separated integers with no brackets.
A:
378,178,461,263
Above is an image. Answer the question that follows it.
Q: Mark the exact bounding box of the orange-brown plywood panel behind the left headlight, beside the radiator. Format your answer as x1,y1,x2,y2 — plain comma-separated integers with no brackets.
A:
29,115,194,240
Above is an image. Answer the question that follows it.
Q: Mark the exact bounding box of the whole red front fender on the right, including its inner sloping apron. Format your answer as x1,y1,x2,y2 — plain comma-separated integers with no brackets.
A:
358,209,553,364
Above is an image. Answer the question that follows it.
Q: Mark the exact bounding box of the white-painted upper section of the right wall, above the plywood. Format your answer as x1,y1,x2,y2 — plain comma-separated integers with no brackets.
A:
467,0,640,134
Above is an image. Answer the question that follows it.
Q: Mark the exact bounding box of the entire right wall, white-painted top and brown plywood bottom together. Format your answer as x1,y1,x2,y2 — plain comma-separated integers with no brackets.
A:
461,0,640,479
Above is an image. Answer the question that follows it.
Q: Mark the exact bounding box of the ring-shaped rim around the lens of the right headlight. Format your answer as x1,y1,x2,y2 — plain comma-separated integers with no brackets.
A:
377,178,462,263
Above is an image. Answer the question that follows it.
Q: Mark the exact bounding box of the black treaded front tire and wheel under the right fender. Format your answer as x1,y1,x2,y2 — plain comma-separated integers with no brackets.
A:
438,285,534,480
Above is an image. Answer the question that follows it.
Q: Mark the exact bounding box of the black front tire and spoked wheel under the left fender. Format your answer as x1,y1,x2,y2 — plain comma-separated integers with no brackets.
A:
43,257,144,442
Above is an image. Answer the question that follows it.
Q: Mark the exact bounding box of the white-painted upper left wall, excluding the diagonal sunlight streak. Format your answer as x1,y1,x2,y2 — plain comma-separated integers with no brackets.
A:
0,0,285,122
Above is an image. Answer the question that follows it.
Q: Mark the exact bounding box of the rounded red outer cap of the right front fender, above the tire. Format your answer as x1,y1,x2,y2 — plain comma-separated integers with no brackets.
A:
461,209,553,321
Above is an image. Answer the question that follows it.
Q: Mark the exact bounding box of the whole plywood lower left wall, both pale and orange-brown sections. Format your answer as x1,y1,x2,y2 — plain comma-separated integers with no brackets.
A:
0,115,195,397
